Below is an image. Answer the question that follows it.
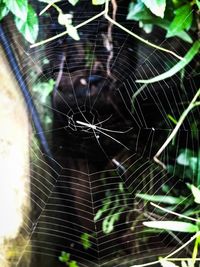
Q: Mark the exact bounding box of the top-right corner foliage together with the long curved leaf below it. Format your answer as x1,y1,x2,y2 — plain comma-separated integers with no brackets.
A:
127,0,200,83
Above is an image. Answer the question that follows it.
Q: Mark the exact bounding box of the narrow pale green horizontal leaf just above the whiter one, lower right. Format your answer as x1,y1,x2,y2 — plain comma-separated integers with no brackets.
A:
136,194,184,205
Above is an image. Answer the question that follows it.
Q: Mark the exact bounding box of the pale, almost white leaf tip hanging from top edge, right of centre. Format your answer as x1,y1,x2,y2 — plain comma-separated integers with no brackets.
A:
142,0,166,18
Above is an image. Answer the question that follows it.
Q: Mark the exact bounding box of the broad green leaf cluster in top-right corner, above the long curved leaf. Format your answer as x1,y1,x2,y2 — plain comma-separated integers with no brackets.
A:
127,0,199,43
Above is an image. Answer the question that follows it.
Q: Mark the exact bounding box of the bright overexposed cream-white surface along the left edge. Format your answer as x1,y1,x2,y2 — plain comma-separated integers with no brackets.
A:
0,47,30,267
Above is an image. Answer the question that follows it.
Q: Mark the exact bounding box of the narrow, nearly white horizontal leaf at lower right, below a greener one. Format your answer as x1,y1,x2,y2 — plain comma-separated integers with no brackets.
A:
143,221,198,233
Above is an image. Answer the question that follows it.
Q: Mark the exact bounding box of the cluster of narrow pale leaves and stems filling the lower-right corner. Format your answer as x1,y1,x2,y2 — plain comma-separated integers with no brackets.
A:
136,148,200,267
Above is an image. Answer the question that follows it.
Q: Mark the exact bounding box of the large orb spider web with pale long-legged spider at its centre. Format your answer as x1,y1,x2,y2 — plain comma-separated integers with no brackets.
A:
3,2,198,267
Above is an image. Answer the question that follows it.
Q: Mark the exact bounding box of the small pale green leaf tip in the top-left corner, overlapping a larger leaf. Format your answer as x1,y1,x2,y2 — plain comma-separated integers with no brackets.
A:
5,0,28,21
